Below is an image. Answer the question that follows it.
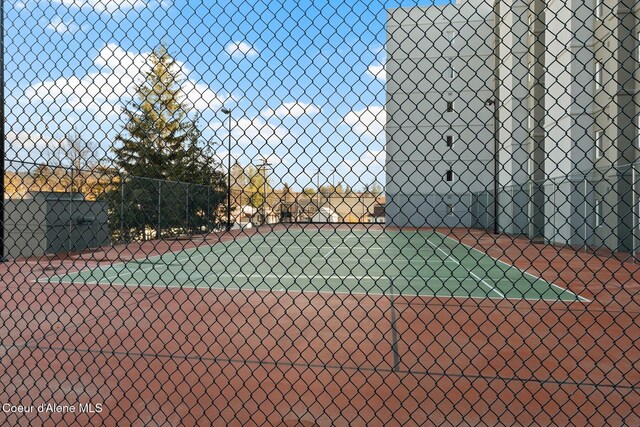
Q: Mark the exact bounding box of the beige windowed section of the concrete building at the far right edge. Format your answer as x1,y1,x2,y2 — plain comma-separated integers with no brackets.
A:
592,0,640,252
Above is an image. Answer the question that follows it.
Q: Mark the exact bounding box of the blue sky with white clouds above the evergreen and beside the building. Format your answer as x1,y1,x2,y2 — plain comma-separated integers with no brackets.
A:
5,0,444,189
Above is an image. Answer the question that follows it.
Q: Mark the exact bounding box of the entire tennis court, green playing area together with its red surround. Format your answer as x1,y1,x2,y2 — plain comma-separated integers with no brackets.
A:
5,225,638,425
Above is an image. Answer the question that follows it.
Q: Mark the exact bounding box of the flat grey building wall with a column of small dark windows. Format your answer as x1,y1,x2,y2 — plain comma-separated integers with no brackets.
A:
385,0,495,227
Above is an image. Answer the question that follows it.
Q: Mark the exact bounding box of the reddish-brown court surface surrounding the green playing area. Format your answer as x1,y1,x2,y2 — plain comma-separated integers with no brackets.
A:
0,226,640,426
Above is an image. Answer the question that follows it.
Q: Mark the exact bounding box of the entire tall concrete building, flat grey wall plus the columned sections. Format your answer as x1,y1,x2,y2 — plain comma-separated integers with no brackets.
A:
387,0,640,252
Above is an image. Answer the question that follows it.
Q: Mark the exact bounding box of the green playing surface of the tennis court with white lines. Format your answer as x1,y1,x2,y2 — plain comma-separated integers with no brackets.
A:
41,230,588,302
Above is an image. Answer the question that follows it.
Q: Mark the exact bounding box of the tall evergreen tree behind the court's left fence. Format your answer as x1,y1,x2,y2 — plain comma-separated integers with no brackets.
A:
112,46,227,238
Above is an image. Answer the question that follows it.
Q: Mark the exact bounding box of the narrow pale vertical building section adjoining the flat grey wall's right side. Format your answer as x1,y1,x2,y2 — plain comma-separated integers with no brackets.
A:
496,0,545,235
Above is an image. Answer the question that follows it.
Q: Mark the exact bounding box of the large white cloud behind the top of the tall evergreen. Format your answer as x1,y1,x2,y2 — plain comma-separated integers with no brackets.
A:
23,44,228,115
